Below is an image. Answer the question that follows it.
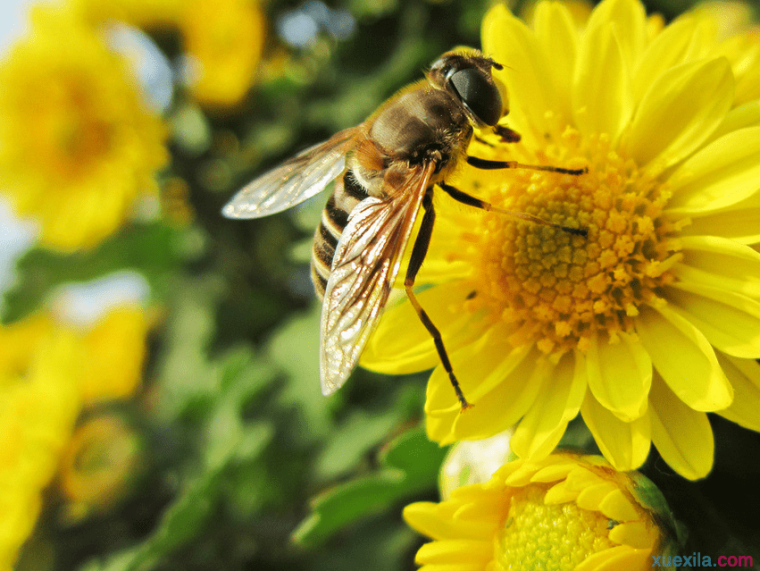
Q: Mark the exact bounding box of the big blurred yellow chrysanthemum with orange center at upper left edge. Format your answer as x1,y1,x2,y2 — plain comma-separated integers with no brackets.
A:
0,7,167,250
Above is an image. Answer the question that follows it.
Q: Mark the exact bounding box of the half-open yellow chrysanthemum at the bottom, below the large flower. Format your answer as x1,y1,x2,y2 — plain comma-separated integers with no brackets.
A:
404,454,674,571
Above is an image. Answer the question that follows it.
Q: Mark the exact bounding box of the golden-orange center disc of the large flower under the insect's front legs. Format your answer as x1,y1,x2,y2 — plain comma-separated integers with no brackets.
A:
468,129,679,353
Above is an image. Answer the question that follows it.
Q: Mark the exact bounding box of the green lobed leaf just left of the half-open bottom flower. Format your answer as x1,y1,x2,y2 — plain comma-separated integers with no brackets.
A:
293,428,446,545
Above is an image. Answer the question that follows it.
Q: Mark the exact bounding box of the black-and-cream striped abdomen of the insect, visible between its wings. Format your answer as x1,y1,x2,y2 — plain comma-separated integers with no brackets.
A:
311,171,368,301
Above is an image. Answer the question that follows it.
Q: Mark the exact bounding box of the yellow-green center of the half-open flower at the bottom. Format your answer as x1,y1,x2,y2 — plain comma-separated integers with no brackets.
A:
494,485,614,571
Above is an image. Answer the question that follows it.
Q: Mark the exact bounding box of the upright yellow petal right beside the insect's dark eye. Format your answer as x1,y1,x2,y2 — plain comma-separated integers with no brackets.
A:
482,4,557,143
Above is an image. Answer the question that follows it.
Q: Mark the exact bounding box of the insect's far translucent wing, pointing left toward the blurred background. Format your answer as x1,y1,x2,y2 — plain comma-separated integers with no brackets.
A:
222,125,361,218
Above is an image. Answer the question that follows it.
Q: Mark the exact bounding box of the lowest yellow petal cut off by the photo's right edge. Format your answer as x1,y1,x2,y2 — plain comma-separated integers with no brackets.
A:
718,353,760,431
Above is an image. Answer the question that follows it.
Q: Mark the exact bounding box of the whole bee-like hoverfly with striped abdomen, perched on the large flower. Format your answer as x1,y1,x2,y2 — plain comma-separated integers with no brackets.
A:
223,50,586,410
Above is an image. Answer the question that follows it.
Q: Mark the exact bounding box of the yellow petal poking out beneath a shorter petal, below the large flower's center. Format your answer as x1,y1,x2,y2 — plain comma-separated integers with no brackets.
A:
581,391,650,471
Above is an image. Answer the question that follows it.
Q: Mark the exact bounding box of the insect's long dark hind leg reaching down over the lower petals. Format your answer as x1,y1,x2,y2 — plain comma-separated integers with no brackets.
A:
404,188,471,410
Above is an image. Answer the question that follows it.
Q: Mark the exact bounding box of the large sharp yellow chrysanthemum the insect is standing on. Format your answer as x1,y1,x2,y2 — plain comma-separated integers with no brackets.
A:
362,0,760,478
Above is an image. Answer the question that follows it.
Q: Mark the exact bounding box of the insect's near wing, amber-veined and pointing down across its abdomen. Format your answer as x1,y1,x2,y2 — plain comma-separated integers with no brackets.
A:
319,163,435,395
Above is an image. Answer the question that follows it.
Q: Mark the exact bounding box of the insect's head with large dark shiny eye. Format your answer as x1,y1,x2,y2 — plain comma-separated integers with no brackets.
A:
428,50,509,127
